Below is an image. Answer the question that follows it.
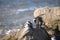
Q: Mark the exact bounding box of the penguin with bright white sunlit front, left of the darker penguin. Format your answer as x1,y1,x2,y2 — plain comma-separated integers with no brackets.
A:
23,20,34,40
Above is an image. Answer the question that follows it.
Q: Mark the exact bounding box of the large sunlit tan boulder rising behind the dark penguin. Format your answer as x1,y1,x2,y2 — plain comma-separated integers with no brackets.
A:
34,7,60,35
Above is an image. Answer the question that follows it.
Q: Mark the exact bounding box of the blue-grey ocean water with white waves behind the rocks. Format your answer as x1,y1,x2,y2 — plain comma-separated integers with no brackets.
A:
0,0,60,37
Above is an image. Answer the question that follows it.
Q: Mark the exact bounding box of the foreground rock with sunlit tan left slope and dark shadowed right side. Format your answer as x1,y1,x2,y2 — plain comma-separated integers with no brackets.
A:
0,22,50,40
